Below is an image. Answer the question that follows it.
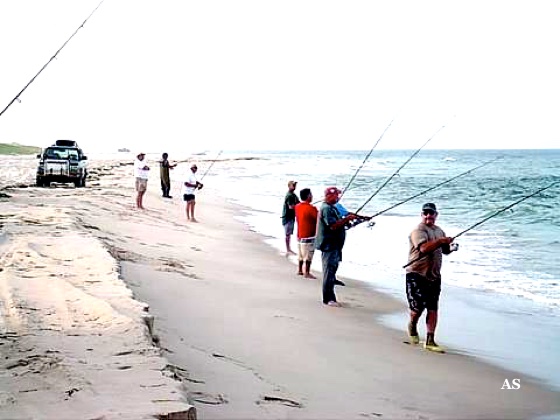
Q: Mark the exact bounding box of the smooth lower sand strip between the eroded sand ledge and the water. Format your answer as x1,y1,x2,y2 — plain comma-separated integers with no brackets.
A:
0,158,560,419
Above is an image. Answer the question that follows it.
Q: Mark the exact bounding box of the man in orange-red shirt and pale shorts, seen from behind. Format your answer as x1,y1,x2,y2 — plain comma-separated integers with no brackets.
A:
294,188,318,279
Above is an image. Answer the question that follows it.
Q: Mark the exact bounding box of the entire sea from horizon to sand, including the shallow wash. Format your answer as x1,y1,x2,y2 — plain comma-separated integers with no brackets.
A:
0,150,560,389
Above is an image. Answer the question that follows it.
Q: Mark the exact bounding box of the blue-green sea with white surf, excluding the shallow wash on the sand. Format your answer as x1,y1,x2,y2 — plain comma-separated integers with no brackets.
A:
207,150,560,316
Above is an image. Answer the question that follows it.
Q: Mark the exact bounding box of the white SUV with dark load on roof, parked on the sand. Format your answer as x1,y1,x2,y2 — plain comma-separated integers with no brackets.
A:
37,140,87,188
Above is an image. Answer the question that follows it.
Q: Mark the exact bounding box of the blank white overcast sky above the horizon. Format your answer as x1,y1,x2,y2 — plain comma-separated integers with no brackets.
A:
0,0,560,152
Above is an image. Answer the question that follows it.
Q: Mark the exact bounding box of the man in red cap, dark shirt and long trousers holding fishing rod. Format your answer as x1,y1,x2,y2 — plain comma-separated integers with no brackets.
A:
315,187,368,306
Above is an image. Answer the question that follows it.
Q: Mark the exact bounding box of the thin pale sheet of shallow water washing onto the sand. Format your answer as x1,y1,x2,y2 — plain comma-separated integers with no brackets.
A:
228,192,560,391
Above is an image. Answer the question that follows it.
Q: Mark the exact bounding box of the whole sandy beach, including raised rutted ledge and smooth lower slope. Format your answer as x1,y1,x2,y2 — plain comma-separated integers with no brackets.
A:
0,158,560,420
